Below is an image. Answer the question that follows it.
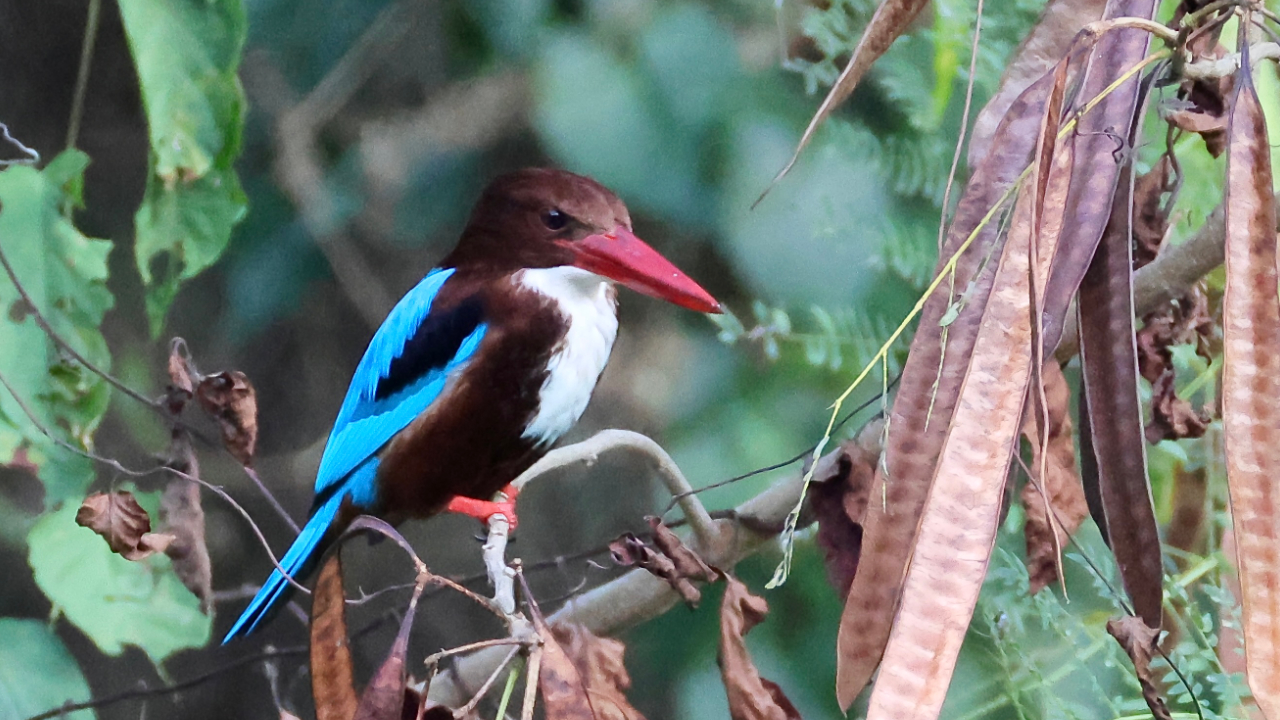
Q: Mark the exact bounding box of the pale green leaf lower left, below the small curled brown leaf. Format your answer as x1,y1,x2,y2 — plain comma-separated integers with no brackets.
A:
27,493,212,664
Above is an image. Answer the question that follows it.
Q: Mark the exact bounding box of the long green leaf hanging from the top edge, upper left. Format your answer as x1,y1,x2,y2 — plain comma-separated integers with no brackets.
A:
120,0,247,336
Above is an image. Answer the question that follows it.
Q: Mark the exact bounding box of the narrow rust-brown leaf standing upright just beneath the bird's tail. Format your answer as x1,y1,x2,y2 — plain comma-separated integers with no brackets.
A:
311,552,358,720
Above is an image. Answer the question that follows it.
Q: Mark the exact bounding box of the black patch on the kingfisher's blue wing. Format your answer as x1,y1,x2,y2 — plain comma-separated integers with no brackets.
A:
374,296,484,402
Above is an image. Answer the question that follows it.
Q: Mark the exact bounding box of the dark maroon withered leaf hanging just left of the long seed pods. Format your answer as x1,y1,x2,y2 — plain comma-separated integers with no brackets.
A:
808,421,884,597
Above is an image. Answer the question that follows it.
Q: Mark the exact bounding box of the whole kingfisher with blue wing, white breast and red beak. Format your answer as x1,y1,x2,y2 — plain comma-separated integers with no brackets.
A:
223,168,723,644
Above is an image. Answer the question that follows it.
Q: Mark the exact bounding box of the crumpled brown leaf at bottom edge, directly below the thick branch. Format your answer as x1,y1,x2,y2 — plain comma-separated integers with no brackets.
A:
550,623,644,720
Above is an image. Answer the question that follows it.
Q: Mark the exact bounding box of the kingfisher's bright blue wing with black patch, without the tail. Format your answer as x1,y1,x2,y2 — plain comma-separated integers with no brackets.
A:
316,269,488,502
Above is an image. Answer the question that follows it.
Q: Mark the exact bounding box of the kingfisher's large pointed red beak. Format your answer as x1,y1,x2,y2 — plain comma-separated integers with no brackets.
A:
567,225,724,313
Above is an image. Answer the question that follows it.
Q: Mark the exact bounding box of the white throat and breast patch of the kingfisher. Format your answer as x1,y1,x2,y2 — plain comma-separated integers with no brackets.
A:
513,266,618,446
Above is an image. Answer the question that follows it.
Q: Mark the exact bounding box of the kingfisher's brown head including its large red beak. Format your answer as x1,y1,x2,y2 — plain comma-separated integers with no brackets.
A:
442,168,721,313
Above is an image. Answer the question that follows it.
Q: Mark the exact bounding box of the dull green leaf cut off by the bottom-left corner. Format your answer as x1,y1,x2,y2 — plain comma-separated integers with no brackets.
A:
0,618,96,720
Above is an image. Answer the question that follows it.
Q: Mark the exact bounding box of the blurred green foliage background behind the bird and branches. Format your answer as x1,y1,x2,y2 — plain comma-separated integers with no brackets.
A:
0,0,1228,719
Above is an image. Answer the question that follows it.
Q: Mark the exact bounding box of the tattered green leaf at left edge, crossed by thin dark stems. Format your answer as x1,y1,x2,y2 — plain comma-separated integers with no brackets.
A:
0,150,113,507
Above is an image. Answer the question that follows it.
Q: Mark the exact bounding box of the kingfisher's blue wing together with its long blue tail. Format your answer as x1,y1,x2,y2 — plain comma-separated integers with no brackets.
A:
223,269,488,643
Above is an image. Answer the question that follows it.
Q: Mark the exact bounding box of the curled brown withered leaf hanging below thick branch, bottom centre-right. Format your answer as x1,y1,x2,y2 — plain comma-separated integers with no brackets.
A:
718,575,800,720
